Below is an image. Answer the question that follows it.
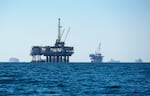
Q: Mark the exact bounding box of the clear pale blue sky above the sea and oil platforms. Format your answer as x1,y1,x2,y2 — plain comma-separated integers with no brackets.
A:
0,0,150,62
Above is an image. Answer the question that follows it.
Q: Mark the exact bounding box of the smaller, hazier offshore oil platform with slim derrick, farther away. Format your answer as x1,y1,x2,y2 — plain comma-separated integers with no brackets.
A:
89,44,104,63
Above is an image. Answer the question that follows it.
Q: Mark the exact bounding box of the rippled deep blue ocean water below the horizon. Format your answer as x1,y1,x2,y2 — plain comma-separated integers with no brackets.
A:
0,63,150,96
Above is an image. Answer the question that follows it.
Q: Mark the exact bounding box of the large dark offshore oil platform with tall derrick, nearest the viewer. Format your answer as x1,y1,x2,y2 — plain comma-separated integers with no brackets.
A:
30,18,74,63
